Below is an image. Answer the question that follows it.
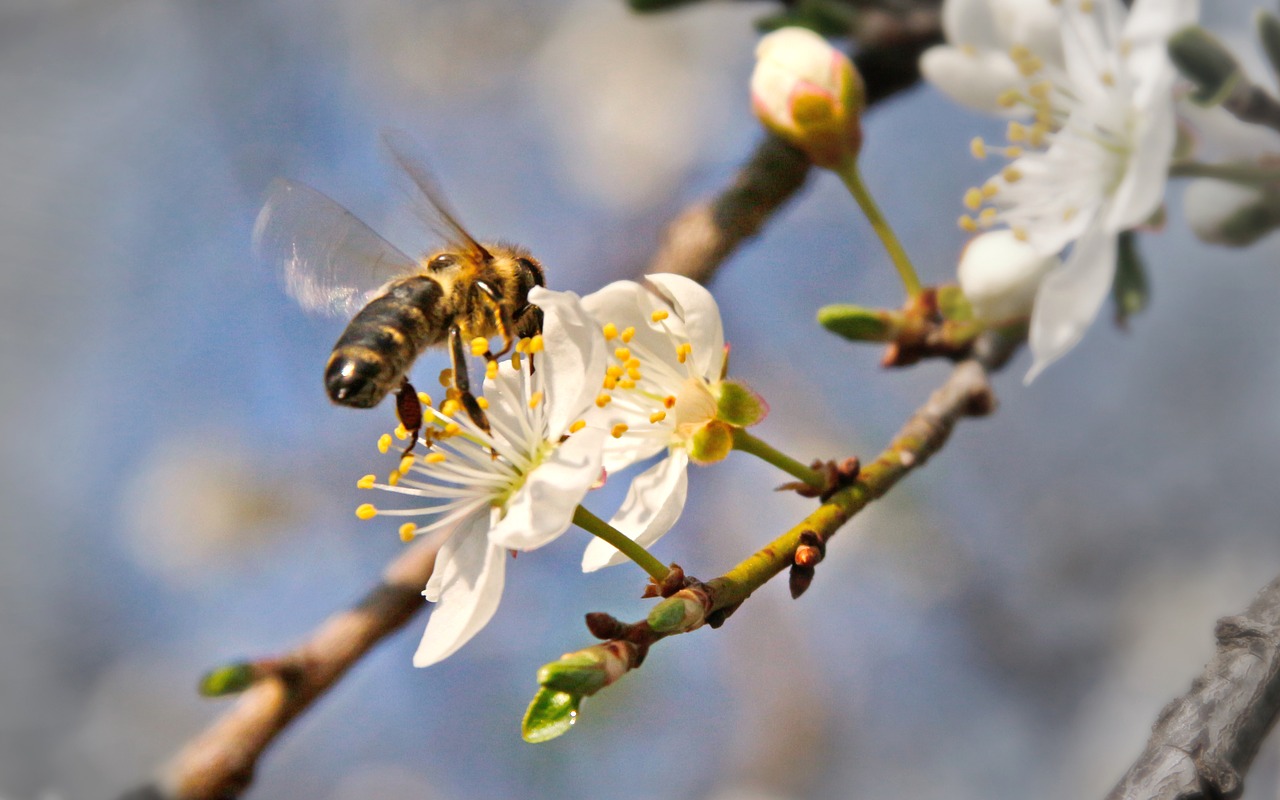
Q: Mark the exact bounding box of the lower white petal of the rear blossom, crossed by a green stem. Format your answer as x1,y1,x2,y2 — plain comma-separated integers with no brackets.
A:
582,449,689,572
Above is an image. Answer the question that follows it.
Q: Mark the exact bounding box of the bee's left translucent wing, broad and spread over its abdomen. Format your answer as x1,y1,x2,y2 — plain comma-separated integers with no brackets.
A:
253,178,421,316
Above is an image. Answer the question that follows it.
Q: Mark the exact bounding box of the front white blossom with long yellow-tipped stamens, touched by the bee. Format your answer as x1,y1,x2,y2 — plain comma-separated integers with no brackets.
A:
356,288,605,667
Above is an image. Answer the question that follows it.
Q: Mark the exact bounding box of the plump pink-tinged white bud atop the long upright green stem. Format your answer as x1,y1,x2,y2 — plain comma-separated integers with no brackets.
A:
751,28,867,169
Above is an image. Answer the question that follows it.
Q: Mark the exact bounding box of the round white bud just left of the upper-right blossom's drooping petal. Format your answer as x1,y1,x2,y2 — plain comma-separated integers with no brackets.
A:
956,229,1059,323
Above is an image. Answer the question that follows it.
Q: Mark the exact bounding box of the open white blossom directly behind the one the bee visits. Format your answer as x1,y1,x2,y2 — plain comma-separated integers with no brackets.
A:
582,275,764,571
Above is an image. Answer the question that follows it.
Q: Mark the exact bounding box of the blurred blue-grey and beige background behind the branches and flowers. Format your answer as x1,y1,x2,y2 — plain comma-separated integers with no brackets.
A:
0,0,1280,800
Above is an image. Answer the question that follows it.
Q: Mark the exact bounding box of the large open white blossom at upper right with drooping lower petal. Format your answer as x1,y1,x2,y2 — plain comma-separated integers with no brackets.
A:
965,0,1197,381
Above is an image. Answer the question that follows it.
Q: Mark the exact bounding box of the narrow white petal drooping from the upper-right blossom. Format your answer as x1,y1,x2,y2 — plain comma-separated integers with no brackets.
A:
1023,216,1116,384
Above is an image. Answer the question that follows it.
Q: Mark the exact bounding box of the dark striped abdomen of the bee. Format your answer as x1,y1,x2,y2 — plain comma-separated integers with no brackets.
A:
324,275,449,408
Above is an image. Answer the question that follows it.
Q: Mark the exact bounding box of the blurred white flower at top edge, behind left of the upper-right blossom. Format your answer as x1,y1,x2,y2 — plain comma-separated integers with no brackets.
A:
920,0,1062,115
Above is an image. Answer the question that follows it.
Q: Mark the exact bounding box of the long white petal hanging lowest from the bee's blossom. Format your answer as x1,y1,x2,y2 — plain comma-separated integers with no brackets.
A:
413,531,507,667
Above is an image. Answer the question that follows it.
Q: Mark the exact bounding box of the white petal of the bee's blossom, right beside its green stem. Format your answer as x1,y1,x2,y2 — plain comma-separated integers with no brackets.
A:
489,428,605,550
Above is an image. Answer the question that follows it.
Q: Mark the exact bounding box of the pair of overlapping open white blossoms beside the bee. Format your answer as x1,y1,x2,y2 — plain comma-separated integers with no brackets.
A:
356,275,763,667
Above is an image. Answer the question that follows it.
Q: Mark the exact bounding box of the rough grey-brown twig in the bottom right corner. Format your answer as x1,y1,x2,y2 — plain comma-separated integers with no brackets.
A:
1107,577,1280,800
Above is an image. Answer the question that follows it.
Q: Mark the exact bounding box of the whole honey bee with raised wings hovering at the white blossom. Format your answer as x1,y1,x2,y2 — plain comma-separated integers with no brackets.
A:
253,134,547,456
